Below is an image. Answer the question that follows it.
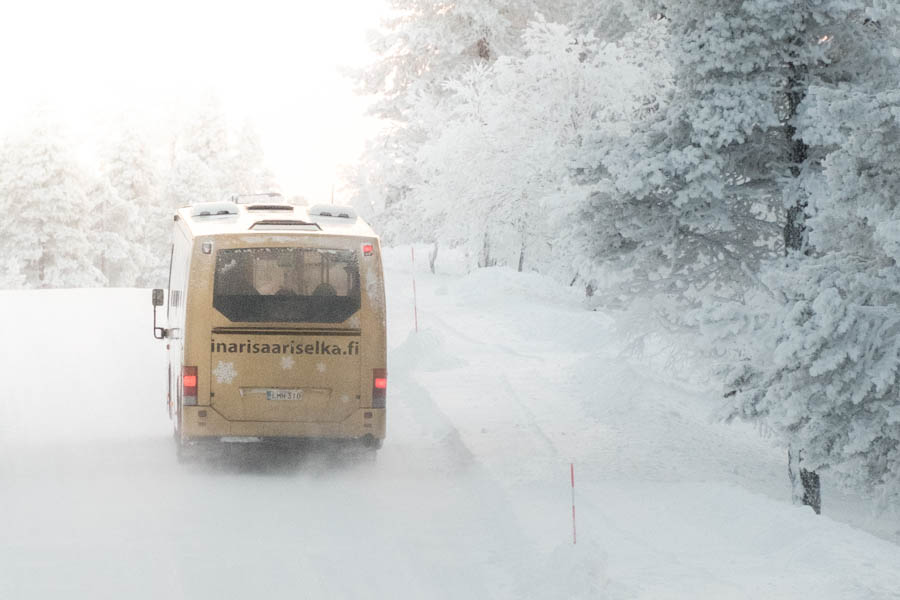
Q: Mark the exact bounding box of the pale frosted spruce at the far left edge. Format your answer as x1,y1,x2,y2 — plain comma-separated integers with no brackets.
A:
0,117,106,288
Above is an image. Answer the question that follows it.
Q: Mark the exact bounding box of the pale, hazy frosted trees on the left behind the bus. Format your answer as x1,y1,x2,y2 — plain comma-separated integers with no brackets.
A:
0,98,275,288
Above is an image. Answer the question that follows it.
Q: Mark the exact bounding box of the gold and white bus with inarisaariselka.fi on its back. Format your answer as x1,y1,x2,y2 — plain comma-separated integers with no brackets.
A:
153,195,387,459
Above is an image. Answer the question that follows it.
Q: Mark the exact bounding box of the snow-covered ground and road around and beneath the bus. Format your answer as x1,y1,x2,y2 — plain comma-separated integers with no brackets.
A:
0,248,900,600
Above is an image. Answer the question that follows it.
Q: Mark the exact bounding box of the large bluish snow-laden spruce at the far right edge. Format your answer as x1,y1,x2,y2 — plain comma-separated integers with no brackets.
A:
729,7,900,502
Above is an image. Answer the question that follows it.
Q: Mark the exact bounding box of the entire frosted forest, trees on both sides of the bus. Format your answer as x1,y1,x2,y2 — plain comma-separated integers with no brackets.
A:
0,0,900,510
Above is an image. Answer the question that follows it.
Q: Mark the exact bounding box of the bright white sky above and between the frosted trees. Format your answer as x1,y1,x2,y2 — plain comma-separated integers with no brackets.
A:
0,0,384,201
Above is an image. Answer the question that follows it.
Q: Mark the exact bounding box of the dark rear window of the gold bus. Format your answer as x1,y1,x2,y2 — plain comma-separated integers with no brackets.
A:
213,248,360,323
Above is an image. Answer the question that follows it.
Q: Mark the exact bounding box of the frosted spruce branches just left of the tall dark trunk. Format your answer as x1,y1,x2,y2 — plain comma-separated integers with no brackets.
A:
582,0,793,316
